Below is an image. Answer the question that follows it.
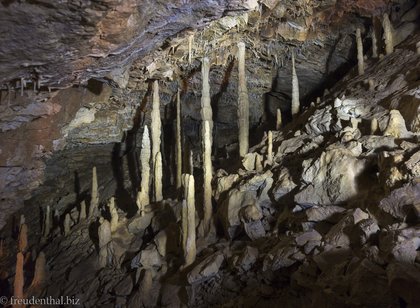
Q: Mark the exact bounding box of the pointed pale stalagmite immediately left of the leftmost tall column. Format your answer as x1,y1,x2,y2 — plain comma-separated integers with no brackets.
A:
136,125,150,215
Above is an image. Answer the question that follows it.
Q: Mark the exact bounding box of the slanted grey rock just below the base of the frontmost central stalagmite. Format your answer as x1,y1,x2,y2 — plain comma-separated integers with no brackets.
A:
187,253,225,284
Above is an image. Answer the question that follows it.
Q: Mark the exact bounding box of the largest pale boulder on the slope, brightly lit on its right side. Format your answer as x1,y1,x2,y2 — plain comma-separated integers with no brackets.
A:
295,148,366,206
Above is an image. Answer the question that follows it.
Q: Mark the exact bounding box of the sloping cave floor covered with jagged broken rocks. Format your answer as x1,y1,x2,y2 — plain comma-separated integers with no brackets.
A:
0,30,420,307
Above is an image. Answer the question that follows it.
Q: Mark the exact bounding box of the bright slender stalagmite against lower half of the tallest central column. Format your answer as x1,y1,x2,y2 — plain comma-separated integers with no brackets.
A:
202,121,213,235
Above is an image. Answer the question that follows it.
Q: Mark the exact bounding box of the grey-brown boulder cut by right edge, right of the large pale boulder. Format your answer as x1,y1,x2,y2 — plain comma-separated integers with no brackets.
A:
379,183,420,221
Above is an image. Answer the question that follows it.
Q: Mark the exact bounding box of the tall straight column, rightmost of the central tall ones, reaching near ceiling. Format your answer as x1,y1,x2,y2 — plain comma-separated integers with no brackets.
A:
238,42,249,157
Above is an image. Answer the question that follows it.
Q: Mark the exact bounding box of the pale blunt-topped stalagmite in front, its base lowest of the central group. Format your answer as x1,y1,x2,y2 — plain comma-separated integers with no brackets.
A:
182,174,196,267
